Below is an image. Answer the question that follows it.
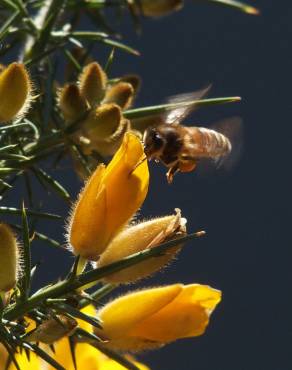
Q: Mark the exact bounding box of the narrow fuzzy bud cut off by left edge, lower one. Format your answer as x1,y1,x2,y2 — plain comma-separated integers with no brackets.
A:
0,224,20,292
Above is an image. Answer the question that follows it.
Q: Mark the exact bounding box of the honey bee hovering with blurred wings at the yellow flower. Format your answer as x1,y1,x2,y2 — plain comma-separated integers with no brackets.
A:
143,88,242,183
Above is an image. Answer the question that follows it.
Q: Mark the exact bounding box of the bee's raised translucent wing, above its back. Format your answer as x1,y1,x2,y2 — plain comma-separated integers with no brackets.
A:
163,85,212,125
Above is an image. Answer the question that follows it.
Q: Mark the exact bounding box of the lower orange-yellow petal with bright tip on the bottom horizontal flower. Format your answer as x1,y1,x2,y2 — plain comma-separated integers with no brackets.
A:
130,284,221,343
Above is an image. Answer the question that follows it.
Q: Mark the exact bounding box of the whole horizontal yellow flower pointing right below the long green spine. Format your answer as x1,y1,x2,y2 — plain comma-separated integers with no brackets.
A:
94,284,221,351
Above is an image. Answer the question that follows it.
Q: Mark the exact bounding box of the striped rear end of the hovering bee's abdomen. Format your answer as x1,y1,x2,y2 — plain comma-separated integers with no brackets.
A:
198,127,232,157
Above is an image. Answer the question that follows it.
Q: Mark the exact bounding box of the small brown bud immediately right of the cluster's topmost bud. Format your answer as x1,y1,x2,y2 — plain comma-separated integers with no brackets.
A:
104,82,134,109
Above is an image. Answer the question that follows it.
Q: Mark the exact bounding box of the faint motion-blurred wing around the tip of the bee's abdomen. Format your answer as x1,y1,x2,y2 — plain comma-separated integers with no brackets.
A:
197,117,243,176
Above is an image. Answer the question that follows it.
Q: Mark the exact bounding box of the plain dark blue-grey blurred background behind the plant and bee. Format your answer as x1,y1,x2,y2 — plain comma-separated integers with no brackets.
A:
8,0,292,370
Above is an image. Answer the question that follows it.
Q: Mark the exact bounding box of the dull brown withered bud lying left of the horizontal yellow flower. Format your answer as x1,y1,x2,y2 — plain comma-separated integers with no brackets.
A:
26,315,78,344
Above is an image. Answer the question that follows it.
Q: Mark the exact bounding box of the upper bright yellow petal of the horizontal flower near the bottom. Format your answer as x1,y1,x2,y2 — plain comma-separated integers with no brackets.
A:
98,284,183,339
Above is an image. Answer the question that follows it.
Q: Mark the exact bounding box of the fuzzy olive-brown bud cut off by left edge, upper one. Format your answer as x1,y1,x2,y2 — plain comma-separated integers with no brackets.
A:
0,63,31,122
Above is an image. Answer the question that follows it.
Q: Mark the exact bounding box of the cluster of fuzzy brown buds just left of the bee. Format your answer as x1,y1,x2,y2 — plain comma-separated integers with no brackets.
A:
59,62,139,156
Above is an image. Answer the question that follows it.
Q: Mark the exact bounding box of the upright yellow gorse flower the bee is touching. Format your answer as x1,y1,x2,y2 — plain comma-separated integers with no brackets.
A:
68,133,149,260
